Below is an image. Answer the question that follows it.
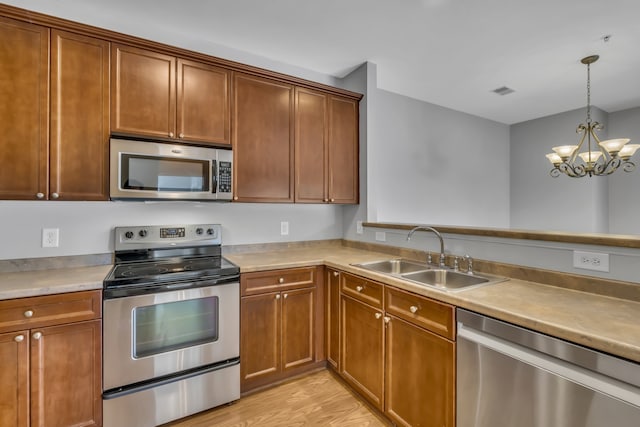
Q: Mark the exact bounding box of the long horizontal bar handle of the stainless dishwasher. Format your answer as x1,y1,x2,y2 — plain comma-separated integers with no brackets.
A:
458,323,640,408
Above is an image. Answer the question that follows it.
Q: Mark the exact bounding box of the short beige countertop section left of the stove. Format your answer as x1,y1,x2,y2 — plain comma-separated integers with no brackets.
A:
0,265,111,300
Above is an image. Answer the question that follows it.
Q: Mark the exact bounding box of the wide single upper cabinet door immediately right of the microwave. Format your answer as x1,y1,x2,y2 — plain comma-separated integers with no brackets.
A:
233,74,294,202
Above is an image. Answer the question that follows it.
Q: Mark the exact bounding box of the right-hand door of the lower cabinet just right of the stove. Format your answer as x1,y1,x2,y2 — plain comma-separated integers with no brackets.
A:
282,288,315,371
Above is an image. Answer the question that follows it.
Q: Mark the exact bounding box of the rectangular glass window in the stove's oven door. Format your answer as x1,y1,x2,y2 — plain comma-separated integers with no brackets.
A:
133,296,218,358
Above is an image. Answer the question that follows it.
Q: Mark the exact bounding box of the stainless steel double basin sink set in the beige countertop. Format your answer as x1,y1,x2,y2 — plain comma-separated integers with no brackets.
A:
352,259,507,292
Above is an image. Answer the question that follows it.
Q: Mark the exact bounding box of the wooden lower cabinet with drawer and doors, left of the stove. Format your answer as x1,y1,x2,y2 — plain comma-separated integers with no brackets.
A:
0,291,102,427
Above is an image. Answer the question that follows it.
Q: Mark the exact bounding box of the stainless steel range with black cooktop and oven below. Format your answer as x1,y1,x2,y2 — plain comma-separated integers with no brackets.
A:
102,224,240,427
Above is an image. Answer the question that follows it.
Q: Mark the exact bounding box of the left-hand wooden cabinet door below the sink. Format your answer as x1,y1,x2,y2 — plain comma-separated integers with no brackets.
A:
341,296,384,410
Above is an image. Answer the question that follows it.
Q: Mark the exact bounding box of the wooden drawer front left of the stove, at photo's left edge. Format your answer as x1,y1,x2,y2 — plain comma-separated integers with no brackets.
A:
0,291,102,333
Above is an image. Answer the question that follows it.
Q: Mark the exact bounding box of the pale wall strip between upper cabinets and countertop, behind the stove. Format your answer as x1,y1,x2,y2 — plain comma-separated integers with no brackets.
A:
0,201,342,259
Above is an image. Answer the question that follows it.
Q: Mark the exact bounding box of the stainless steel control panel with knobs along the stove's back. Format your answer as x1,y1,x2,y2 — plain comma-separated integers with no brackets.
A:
115,224,222,251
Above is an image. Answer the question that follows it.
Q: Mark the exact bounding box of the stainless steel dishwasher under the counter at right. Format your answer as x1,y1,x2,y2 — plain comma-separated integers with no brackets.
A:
456,309,640,427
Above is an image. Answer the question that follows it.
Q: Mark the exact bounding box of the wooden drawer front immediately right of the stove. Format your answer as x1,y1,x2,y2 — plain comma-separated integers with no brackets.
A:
240,267,316,296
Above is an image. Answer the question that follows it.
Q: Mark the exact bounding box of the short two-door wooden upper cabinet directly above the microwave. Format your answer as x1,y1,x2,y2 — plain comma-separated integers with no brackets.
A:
111,45,231,145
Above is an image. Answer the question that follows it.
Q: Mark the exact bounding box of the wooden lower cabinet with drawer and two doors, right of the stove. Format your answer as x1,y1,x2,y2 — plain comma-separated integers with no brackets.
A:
240,267,323,392
